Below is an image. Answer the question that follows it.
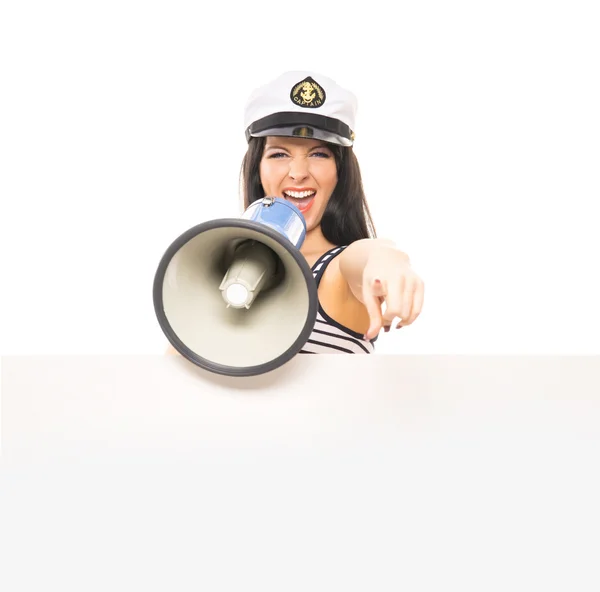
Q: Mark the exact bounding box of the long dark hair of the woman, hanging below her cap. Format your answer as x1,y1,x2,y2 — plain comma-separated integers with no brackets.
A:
240,138,377,245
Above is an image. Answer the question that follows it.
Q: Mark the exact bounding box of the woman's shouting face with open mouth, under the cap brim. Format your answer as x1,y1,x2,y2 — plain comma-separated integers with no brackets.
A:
260,136,338,231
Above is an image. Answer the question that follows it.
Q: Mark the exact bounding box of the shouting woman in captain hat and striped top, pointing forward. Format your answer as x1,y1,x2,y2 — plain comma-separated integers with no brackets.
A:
241,72,424,353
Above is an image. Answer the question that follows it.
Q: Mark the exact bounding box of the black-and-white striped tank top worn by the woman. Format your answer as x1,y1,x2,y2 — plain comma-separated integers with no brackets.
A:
299,245,377,354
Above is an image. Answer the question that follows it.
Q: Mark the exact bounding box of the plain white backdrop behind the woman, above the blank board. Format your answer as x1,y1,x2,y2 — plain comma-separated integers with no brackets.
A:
0,0,600,354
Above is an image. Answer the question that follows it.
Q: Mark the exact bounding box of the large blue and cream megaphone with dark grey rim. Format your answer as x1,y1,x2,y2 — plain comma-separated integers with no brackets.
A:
153,197,318,376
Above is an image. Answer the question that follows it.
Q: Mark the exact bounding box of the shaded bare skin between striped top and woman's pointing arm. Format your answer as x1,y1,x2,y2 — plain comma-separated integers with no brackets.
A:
319,256,370,333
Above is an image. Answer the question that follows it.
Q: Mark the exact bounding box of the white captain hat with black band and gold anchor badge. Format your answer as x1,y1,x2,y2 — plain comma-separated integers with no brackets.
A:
244,71,357,146
